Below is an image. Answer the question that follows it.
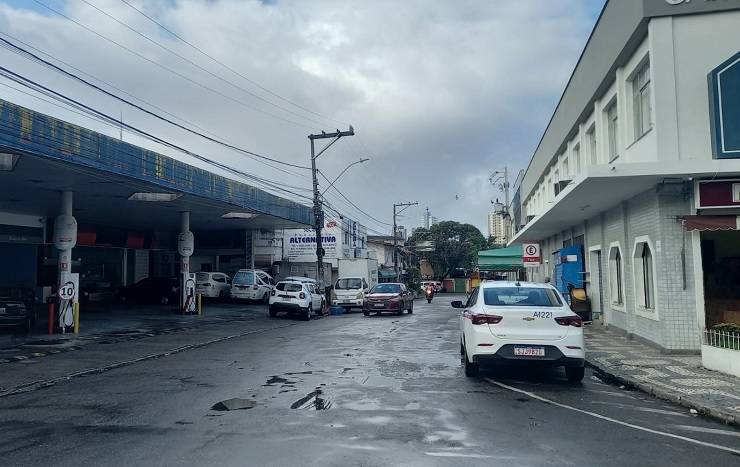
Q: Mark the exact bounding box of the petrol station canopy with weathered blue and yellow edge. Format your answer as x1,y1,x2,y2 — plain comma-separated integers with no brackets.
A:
0,100,313,230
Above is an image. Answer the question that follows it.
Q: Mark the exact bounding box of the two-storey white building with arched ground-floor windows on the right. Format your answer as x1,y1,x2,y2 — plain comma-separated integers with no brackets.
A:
512,0,740,350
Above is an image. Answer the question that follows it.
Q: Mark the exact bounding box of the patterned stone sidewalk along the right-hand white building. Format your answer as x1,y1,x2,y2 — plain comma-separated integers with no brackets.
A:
584,324,740,424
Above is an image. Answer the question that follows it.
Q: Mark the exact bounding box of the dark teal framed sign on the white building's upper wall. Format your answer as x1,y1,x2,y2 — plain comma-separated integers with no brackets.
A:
708,52,740,159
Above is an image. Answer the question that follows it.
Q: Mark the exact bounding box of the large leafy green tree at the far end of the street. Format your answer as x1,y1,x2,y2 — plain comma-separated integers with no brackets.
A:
409,221,488,278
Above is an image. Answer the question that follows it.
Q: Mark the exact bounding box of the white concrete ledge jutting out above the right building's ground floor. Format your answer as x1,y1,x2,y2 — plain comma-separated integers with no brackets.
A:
509,159,740,245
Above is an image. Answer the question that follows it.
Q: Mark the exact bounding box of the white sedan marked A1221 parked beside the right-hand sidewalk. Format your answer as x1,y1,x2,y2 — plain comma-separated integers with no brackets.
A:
452,281,586,382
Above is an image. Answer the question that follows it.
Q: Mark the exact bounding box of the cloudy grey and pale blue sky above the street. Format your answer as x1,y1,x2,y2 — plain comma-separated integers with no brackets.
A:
0,0,603,234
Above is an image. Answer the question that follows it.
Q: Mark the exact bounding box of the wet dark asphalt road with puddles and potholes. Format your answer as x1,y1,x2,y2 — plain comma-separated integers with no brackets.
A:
0,296,740,466
